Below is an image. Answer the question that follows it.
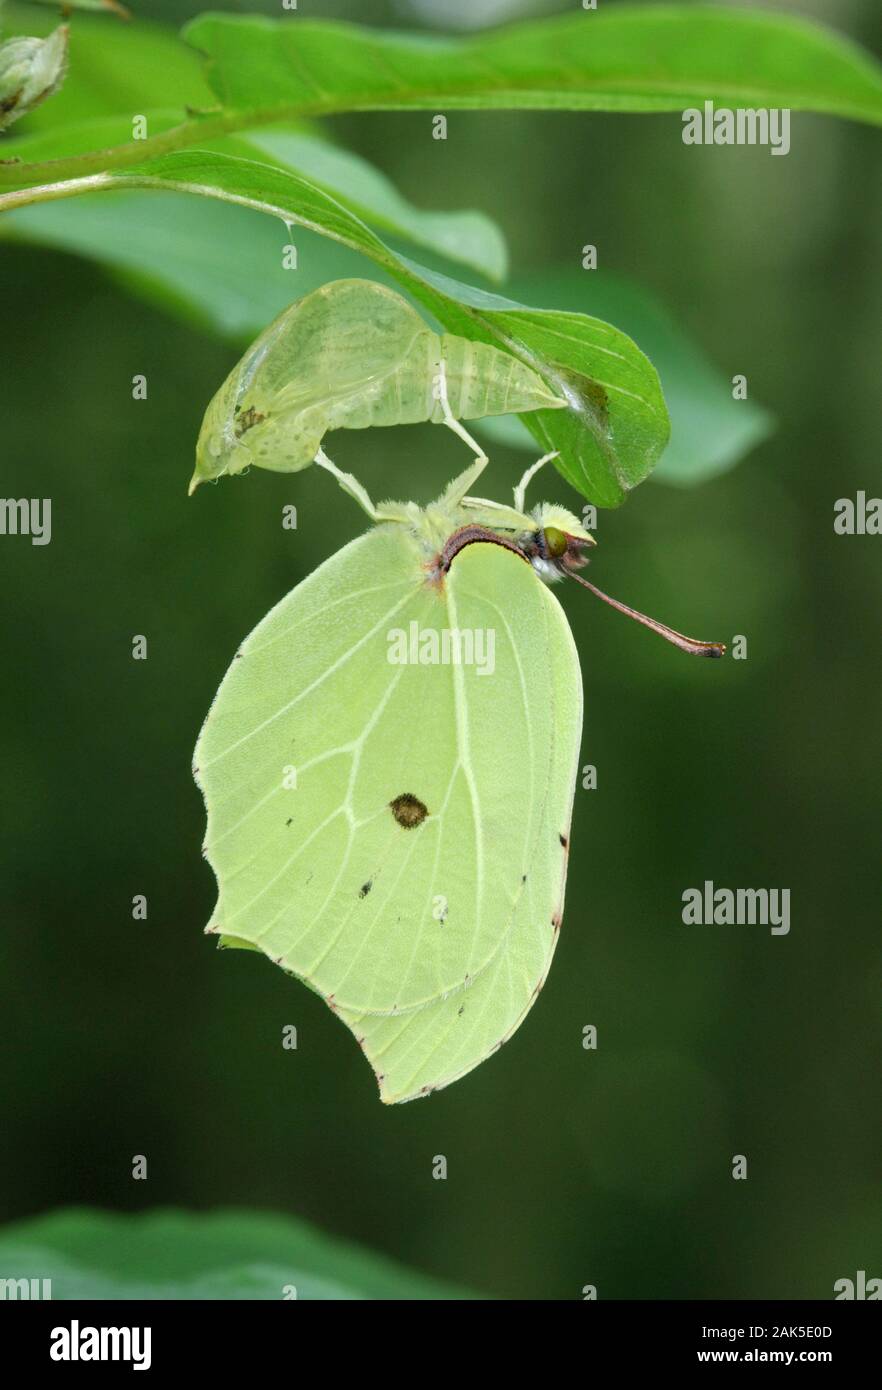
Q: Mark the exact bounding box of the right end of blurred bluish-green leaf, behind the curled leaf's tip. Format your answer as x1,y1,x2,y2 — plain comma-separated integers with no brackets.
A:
476,270,774,487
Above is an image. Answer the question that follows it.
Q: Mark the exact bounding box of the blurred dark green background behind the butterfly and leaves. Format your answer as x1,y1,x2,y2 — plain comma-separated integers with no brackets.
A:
0,0,882,1298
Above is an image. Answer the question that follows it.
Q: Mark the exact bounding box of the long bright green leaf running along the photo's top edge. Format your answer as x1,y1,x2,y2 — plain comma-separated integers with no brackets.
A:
183,4,882,124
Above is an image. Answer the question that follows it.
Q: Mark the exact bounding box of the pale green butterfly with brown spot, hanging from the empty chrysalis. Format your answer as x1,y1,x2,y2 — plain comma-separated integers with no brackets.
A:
194,284,721,1102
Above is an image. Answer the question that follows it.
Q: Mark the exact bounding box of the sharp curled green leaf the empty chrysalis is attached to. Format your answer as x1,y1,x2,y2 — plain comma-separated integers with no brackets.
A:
76,152,669,506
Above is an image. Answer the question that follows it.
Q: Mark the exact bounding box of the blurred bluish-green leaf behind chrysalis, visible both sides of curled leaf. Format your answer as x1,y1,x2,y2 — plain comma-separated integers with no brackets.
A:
0,169,774,487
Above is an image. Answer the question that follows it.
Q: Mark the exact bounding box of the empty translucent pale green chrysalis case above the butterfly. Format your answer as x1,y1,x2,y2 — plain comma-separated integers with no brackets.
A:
190,279,567,492
